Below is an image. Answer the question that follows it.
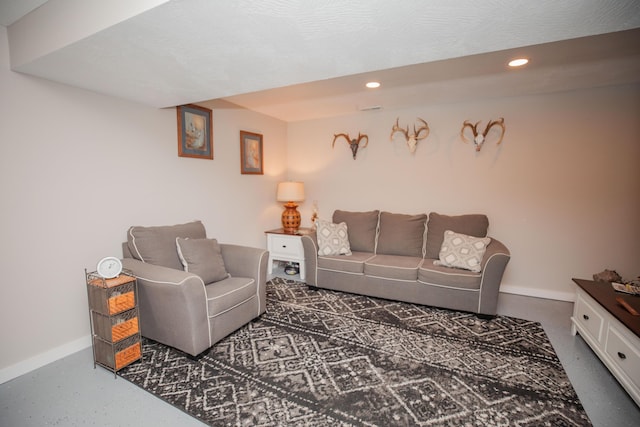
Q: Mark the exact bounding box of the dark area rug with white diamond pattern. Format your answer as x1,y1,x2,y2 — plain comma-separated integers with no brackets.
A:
119,279,591,426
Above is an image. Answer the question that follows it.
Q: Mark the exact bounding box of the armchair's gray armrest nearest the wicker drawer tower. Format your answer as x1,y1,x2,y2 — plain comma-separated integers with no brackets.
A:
122,258,211,356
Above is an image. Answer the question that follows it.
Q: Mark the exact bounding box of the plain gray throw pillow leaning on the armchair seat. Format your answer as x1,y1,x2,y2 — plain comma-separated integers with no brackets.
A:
176,237,229,283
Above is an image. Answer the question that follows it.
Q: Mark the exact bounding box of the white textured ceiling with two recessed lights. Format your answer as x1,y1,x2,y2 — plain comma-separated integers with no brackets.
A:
0,0,640,121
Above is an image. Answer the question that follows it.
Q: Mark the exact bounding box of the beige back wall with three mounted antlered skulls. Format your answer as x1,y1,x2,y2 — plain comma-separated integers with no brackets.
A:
288,85,640,299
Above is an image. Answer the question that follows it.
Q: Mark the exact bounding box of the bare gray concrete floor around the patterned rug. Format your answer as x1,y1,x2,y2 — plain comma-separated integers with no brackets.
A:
0,294,640,427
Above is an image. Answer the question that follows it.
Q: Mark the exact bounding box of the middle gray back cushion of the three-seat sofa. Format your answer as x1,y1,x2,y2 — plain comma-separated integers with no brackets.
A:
376,212,427,258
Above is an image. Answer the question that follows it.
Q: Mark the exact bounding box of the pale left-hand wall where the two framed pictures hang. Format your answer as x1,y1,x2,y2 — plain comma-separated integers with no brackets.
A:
0,27,287,382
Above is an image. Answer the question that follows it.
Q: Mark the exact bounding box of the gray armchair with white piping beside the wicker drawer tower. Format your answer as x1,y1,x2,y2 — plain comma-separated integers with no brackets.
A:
122,221,268,356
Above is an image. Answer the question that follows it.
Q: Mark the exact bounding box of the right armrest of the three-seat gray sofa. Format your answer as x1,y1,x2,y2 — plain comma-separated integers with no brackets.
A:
478,237,511,316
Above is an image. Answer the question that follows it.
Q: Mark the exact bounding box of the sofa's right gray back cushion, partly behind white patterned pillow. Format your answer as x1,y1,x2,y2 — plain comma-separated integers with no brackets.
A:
425,212,489,259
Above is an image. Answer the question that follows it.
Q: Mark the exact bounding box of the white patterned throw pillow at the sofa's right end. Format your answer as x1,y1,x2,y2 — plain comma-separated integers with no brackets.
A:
433,230,491,273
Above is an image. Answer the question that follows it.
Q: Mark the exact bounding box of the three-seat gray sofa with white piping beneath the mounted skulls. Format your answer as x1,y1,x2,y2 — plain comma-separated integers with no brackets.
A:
302,210,510,316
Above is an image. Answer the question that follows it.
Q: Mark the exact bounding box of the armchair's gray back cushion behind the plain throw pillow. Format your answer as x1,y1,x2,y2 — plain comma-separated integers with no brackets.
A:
127,221,207,270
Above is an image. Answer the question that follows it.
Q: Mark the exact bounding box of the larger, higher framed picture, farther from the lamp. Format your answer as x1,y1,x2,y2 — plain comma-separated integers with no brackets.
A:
176,104,213,159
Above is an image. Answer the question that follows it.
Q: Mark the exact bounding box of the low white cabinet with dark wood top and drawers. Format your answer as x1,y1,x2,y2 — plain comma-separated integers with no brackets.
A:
571,279,640,405
